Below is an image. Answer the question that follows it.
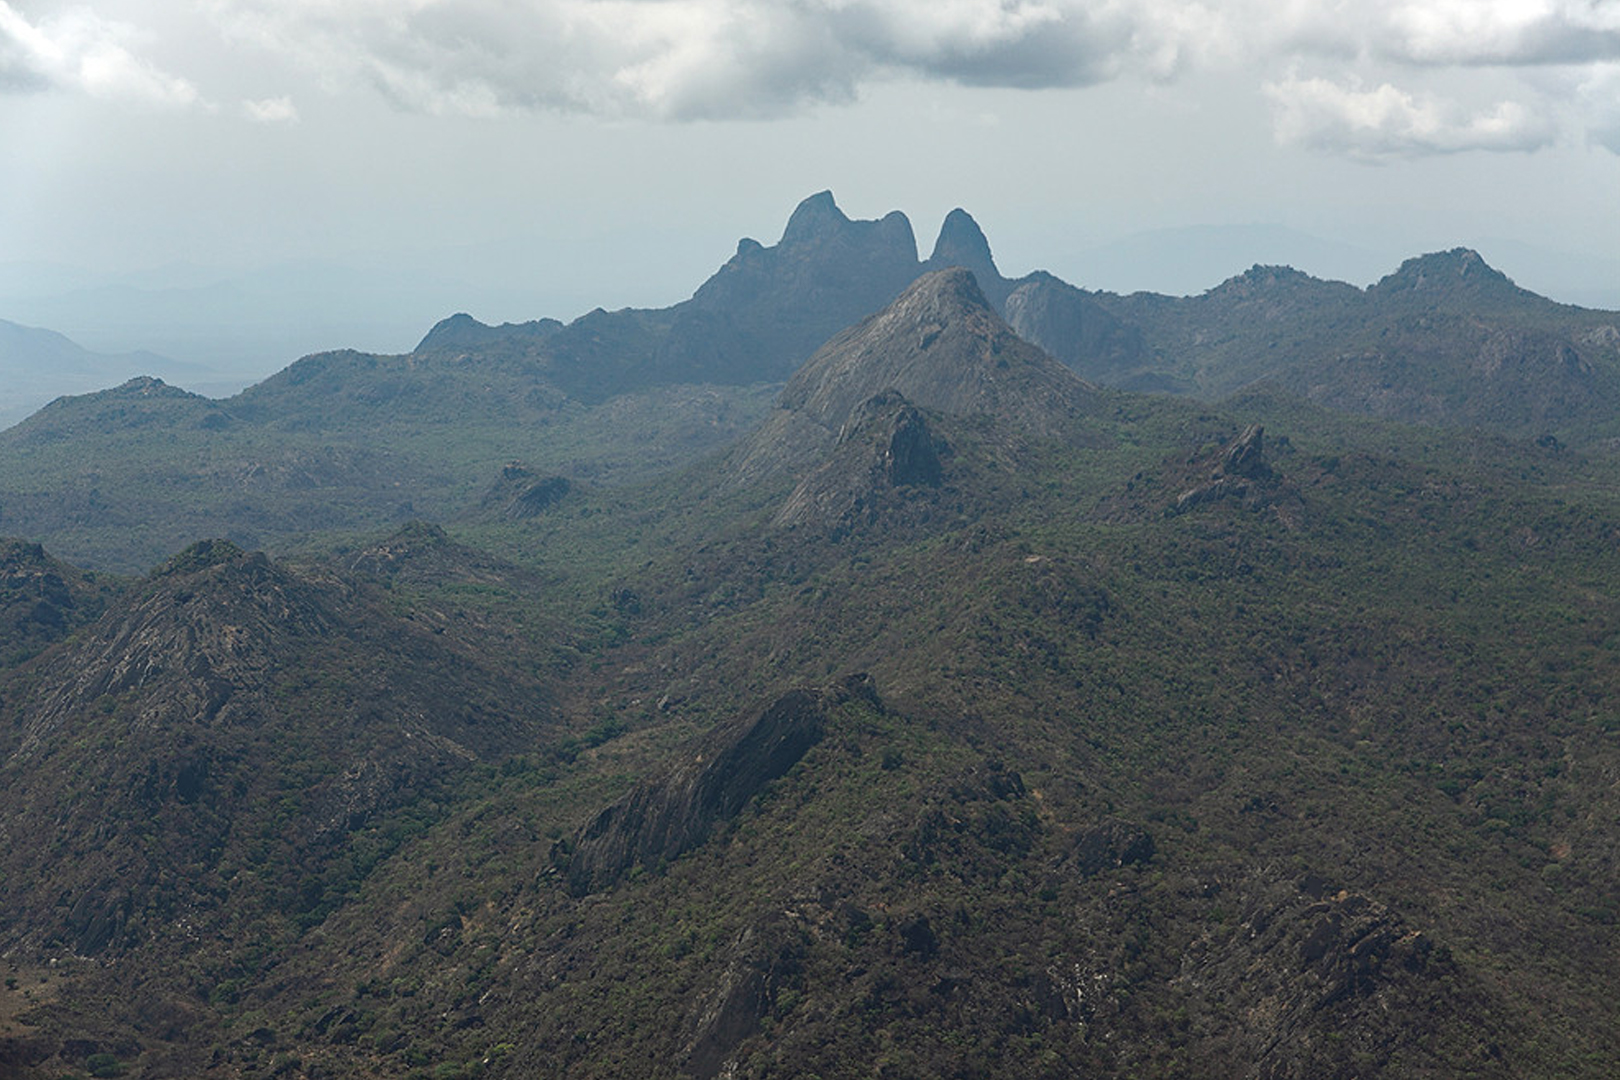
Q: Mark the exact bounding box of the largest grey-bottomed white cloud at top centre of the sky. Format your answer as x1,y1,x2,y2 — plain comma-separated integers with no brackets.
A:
202,0,1212,120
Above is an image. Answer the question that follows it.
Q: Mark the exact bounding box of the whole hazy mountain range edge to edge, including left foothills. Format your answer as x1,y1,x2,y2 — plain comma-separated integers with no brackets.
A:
0,191,1620,570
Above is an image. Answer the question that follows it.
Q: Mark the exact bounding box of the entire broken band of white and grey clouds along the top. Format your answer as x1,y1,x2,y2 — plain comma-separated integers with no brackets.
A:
0,0,1620,155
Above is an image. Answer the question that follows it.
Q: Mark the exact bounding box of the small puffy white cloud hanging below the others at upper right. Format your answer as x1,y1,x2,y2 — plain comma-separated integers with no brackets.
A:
1265,78,1557,160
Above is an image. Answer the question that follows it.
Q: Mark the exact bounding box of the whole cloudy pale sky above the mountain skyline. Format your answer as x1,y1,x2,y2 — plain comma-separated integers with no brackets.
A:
0,0,1620,382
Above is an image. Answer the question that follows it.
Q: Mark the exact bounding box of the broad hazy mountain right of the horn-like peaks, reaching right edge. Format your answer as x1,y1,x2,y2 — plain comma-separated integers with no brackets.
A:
1082,249,1620,444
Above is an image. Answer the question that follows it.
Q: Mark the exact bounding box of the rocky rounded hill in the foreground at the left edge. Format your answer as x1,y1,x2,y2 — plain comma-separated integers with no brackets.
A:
0,541,549,955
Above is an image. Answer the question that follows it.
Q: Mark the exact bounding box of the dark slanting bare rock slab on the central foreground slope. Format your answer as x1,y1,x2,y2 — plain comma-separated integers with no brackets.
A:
557,687,870,895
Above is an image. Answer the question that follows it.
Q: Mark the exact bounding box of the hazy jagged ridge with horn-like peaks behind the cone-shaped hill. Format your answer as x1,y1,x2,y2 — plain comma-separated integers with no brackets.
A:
416,191,1620,440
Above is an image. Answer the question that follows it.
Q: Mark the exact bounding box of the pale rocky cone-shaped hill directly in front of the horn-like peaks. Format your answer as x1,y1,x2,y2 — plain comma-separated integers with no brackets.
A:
781,267,1095,434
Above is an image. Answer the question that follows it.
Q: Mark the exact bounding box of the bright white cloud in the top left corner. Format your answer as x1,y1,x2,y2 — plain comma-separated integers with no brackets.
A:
0,0,201,107
